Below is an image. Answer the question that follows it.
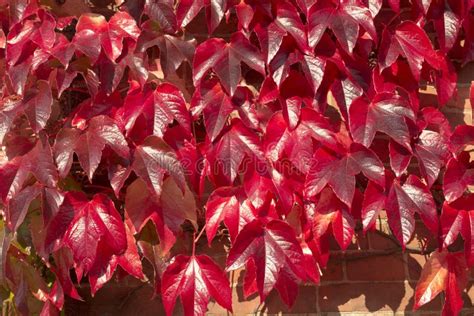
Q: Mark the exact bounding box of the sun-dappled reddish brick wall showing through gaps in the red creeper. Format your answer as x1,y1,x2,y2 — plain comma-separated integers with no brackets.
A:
60,3,474,316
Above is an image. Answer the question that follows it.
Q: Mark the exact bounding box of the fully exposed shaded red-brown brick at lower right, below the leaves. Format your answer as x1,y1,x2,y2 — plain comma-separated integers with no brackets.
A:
346,254,405,281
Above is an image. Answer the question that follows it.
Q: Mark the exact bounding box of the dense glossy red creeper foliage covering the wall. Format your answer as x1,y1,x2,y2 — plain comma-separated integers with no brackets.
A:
0,0,474,315
